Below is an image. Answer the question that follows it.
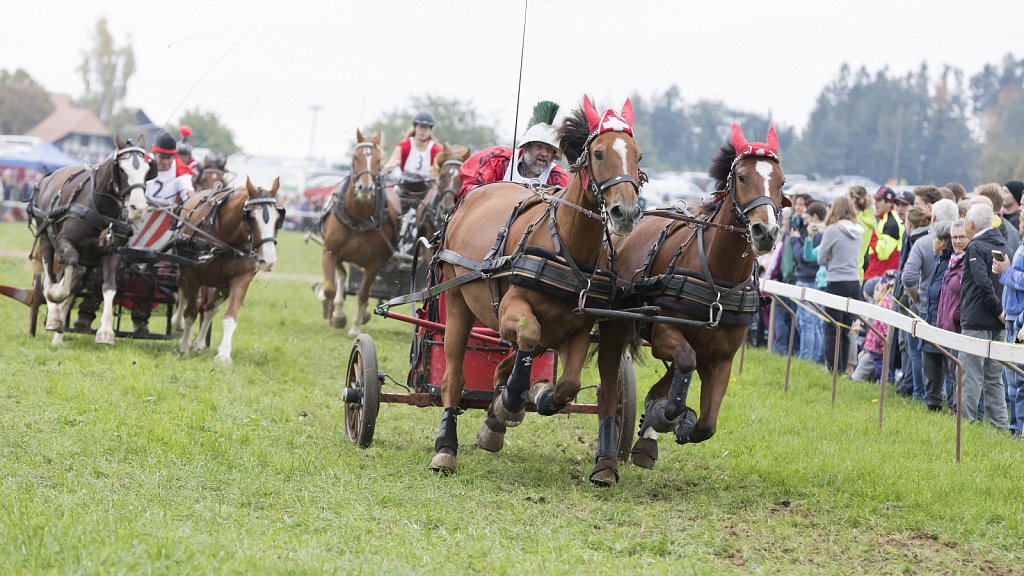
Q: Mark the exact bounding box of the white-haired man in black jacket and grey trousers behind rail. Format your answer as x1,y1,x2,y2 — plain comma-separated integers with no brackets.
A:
961,204,1010,429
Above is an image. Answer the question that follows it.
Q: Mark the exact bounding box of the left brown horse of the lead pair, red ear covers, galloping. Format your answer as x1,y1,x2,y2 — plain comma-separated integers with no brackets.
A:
430,96,641,474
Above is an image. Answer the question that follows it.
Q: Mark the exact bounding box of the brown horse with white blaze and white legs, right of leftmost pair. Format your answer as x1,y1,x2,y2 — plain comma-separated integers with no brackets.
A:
173,178,285,364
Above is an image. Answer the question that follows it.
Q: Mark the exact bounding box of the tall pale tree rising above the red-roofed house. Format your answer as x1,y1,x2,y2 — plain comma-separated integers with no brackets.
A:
78,17,135,126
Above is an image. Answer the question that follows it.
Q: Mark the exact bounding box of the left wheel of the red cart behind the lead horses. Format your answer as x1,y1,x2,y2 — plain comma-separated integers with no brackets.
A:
341,334,381,448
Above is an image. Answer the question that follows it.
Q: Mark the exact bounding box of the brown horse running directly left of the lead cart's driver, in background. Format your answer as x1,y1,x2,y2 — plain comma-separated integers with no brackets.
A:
317,130,398,336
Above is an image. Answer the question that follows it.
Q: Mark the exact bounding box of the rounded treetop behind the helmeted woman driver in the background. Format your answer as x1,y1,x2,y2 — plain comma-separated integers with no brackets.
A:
364,94,499,151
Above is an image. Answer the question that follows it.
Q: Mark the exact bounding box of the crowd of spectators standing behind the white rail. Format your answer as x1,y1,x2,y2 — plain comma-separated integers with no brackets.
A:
761,180,1024,437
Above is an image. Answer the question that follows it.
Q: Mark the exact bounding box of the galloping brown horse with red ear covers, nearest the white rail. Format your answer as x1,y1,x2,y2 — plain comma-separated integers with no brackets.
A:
598,125,784,475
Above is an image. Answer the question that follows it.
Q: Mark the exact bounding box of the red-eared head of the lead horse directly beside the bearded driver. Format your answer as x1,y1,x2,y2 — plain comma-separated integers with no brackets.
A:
559,95,645,236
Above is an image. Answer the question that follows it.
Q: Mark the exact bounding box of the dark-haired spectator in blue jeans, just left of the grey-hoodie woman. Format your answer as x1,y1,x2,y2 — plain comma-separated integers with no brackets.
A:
788,202,825,364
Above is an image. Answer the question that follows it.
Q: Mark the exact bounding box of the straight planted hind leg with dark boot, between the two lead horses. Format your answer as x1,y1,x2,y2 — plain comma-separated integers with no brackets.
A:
590,321,630,487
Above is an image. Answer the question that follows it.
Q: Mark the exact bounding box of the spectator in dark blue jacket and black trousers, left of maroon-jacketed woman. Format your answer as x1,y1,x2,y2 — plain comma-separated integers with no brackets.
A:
925,218,956,412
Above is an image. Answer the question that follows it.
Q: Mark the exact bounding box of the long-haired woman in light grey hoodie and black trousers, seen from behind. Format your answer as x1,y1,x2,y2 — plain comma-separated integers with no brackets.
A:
817,196,863,370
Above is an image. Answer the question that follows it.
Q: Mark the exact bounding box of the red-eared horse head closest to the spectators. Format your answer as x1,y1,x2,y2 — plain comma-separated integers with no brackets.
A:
723,124,785,255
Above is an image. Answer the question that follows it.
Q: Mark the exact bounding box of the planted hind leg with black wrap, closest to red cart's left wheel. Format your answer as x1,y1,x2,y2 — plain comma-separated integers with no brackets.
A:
430,289,474,474
